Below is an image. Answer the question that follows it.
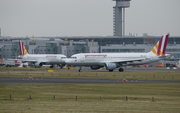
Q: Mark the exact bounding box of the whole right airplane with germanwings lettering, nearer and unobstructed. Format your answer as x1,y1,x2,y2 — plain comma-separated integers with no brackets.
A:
66,34,170,72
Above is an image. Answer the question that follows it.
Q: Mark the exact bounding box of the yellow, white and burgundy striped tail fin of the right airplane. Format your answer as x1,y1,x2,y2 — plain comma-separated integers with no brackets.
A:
151,34,169,56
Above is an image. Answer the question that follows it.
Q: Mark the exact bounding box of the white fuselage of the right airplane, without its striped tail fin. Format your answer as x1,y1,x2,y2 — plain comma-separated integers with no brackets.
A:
66,52,169,66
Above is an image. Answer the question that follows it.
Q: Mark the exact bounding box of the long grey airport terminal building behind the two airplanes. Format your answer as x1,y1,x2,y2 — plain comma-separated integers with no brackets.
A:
0,35,180,66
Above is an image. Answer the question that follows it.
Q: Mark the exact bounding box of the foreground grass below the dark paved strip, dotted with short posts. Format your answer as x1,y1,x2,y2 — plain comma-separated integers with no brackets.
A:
0,84,180,113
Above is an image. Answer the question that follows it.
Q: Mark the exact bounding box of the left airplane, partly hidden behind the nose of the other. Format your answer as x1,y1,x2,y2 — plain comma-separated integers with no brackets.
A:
18,40,66,69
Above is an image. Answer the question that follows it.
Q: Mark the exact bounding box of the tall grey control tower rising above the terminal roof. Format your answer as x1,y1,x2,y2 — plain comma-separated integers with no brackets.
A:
113,0,131,36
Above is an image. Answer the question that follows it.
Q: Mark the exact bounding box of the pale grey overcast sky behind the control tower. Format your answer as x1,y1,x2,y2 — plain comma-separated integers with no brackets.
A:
0,0,180,37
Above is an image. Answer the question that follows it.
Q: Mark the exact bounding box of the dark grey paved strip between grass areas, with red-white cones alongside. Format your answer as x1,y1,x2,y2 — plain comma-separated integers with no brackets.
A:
0,78,180,85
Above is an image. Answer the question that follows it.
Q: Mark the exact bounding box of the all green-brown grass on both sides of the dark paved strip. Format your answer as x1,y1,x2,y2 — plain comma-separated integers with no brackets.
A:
0,68,180,113
